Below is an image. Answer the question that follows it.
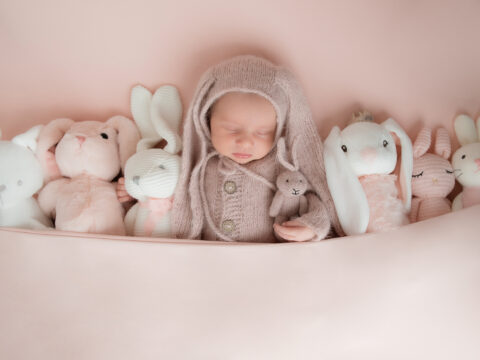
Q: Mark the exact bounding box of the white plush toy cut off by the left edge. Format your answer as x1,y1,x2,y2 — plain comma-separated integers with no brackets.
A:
0,125,52,230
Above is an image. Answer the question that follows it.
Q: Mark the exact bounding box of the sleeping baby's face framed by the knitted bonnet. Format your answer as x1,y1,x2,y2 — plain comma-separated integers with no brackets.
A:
210,92,277,164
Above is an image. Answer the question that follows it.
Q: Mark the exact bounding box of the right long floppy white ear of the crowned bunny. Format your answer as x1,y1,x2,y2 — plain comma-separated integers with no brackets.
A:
382,118,413,211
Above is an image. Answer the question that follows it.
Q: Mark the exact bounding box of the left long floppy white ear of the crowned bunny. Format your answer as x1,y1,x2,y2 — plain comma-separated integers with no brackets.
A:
323,126,370,235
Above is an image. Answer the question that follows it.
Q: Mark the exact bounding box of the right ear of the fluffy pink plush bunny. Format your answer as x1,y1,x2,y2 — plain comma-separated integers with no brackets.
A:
107,115,140,171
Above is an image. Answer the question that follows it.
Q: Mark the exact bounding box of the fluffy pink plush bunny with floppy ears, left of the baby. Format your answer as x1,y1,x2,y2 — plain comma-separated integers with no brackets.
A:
37,116,140,235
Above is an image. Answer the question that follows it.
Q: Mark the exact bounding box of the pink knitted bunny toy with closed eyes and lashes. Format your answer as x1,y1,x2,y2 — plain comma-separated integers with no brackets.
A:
410,127,455,222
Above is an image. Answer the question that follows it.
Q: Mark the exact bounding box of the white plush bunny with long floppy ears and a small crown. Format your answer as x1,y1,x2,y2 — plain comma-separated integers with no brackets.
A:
324,113,413,235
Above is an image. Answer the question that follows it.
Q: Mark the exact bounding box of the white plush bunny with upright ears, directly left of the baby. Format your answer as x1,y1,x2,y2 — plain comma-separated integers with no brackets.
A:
125,85,182,237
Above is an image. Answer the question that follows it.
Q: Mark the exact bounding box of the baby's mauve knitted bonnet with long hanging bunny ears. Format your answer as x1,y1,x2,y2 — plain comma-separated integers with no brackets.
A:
172,55,343,239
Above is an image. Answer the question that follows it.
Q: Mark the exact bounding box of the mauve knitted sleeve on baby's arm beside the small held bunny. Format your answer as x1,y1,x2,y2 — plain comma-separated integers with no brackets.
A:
297,192,331,240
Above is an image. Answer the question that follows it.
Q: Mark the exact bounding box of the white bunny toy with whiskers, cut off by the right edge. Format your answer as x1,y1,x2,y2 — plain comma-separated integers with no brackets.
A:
452,115,480,211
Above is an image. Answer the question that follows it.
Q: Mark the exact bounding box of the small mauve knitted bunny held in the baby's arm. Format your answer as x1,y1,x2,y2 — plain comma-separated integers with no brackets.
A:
270,138,309,224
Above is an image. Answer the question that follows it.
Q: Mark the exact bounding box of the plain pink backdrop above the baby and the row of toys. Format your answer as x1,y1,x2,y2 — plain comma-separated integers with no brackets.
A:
0,0,480,144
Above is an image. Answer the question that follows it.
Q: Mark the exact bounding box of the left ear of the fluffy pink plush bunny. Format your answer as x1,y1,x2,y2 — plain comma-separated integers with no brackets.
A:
36,119,75,182
